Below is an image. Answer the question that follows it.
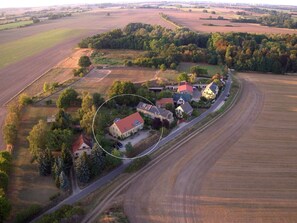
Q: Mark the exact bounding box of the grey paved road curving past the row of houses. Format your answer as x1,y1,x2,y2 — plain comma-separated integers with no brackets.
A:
31,74,231,220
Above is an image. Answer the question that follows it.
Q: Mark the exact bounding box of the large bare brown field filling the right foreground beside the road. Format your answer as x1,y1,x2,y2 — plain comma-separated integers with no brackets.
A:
124,74,297,223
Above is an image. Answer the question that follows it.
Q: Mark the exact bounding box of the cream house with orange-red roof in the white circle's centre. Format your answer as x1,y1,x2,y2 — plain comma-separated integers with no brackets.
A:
109,112,144,139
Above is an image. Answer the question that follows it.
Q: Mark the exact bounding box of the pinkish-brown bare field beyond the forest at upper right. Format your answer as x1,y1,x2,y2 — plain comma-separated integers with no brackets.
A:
166,9,297,34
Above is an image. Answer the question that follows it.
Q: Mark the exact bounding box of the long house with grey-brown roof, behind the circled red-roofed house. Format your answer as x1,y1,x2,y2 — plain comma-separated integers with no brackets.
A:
136,102,174,123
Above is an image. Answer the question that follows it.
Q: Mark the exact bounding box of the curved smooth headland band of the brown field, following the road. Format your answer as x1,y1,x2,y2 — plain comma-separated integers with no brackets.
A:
124,76,264,223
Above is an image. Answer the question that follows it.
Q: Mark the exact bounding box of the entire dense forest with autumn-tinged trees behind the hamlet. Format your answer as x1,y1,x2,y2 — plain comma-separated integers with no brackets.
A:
79,23,297,73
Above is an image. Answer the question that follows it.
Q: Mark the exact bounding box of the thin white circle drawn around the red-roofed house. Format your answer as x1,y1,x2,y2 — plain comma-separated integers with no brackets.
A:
92,94,164,160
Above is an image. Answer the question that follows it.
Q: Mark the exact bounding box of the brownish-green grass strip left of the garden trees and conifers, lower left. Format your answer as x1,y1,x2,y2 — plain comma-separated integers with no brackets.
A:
8,106,60,216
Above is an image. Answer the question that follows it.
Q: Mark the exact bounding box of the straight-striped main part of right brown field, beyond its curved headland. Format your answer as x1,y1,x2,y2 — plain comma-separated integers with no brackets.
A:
199,73,297,222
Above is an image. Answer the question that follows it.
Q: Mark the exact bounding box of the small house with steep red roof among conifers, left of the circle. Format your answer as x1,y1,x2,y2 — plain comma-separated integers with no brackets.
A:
72,134,92,158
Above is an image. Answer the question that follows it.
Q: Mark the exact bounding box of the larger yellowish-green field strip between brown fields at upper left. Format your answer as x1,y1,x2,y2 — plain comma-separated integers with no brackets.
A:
0,29,81,68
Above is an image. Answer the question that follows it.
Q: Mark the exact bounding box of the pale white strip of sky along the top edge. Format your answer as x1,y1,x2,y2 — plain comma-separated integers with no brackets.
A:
0,0,297,9
